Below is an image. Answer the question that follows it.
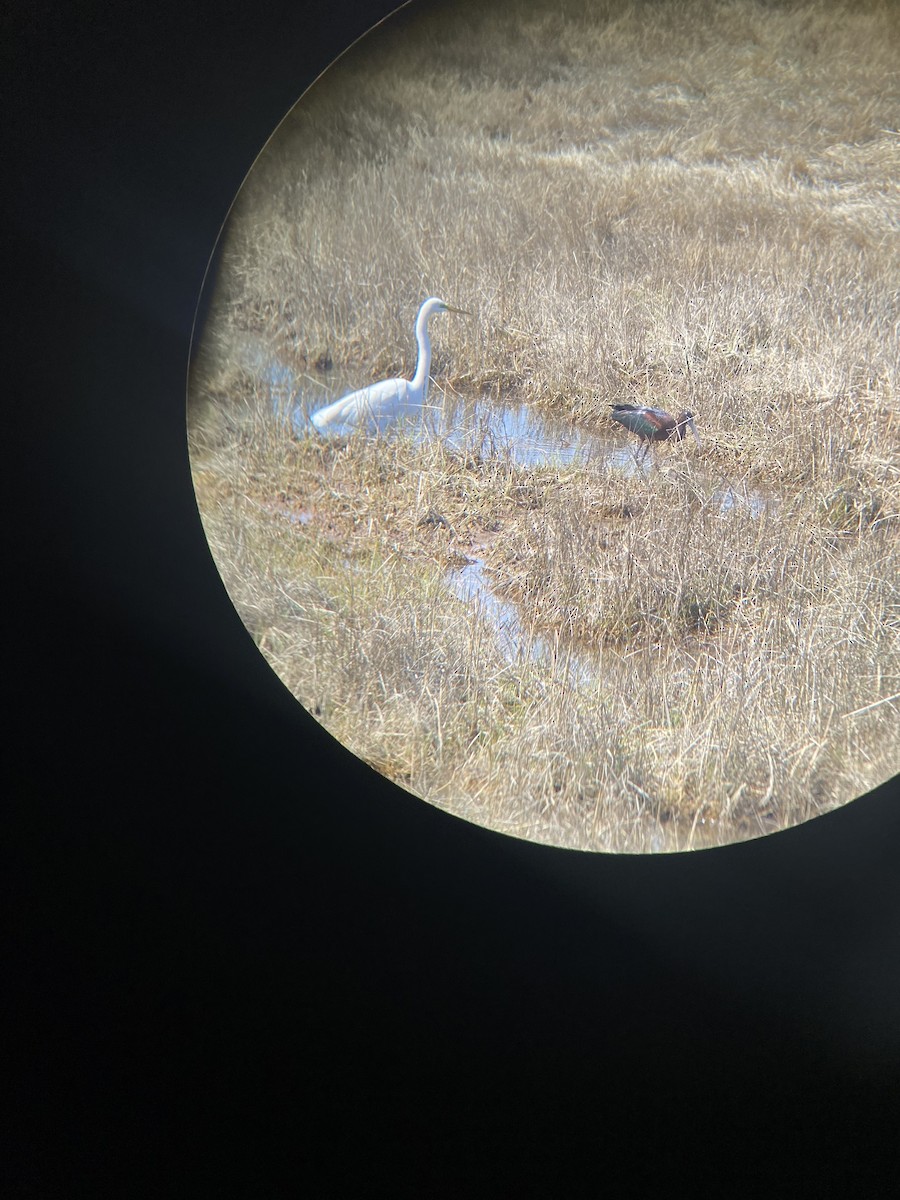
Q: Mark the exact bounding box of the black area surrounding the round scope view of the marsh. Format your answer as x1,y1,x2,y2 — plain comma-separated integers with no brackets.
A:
1,0,900,1198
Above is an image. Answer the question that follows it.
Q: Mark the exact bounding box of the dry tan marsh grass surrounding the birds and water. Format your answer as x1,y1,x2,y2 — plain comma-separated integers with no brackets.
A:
188,0,900,852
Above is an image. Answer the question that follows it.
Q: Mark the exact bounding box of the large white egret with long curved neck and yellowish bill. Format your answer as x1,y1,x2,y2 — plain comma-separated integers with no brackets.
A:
311,296,468,433
